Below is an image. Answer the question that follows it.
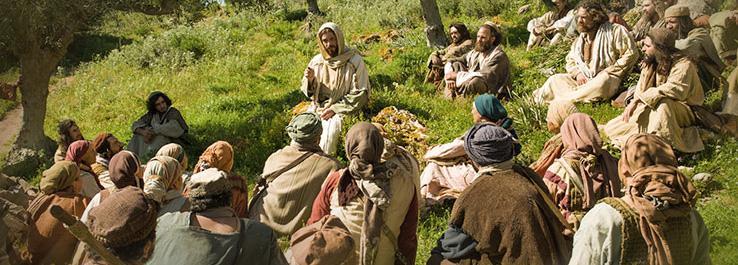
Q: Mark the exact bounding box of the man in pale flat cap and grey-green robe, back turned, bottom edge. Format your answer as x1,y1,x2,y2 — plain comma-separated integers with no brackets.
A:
147,168,287,265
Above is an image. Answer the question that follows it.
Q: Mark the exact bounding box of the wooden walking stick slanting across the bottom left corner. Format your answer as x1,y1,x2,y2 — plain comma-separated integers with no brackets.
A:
50,205,125,265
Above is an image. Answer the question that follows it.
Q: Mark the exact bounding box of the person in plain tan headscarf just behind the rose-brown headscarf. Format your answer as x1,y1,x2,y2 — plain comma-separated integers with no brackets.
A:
530,100,579,176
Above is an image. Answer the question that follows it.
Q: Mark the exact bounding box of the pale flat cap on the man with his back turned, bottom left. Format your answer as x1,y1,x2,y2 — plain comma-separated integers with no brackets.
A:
187,168,231,198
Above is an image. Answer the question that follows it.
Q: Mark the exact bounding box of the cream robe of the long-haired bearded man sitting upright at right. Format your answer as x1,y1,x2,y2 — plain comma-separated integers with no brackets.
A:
533,22,639,104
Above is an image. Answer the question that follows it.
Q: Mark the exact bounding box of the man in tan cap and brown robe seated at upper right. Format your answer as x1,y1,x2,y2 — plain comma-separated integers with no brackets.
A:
664,5,725,90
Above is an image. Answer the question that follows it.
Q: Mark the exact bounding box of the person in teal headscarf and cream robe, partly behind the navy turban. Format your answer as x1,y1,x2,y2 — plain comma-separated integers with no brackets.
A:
420,94,521,205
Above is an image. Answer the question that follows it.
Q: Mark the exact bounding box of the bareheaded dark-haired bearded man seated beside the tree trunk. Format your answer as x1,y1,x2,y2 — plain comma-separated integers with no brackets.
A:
426,23,474,88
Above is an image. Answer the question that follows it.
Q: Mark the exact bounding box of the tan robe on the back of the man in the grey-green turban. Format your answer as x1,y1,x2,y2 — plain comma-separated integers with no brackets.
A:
249,146,340,235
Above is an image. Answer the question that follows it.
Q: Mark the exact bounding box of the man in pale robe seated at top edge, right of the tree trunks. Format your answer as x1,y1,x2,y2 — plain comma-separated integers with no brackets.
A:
526,0,575,50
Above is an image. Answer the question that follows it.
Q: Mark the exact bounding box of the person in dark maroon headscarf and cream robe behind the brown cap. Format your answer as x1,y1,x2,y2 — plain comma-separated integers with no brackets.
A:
72,150,143,265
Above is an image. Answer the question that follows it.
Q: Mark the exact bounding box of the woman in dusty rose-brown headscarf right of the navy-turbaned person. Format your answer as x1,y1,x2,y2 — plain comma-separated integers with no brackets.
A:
543,113,621,228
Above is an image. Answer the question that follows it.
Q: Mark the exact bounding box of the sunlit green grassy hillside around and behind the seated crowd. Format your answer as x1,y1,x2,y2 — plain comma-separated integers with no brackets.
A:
31,0,738,264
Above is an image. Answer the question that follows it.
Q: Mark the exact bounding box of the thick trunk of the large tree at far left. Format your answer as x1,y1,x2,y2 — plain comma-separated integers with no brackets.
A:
15,49,61,150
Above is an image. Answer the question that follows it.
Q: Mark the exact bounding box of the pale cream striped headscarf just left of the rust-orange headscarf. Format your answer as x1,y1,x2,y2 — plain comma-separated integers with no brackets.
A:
144,156,182,203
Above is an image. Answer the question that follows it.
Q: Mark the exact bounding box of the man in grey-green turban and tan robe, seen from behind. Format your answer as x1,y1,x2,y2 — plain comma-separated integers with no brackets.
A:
249,112,340,236
